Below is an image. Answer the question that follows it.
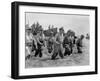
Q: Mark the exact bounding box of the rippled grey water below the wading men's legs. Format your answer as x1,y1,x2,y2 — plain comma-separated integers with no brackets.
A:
25,40,89,68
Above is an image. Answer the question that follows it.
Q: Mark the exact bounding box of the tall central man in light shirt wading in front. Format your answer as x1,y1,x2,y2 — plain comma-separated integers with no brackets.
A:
51,27,64,60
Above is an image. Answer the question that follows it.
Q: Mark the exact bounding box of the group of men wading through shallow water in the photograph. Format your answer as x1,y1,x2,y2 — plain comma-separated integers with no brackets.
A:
26,27,84,60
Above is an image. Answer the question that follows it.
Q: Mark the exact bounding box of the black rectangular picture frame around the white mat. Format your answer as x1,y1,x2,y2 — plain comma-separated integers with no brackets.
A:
11,2,98,79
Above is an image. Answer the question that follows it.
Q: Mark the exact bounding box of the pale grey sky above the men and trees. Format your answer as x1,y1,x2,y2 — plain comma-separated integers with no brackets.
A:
25,12,90,35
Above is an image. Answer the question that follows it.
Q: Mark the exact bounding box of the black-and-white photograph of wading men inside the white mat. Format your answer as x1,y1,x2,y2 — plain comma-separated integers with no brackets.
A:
25,12,90,68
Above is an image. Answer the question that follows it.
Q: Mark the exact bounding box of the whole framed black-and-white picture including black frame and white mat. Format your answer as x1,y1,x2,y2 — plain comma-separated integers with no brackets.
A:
11,2,97,79
